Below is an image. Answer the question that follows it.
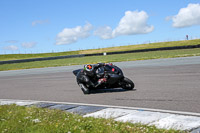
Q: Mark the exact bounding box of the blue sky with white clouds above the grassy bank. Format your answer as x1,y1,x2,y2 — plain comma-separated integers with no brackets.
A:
0,0,200,54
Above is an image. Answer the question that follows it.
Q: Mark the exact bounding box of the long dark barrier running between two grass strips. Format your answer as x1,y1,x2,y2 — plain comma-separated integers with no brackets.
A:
0,44,200,65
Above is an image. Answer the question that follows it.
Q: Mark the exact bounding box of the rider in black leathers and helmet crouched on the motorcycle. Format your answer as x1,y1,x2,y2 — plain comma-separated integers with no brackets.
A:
77,63,112,90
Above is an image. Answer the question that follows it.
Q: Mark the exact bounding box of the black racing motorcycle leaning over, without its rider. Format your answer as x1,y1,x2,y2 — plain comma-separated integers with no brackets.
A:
73,64,135,94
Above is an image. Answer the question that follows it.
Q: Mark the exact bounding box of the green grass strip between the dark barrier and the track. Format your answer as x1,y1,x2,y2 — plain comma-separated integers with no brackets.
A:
0,48,200,71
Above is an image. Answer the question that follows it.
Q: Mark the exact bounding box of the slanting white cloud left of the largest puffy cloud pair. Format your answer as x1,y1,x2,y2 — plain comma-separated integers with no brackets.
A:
56,23,92,45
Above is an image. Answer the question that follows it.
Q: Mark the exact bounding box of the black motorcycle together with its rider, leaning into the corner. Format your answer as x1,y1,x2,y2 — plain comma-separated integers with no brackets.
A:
73,63,135,94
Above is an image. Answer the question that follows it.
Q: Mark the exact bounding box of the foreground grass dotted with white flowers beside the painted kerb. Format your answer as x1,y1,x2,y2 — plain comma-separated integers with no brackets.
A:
0,105,183,133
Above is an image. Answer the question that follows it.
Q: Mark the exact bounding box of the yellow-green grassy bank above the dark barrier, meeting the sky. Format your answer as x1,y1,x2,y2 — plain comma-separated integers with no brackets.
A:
0,39,200,61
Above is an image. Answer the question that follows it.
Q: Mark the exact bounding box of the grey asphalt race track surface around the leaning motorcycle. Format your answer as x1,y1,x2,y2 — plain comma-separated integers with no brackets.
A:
0,56,200,113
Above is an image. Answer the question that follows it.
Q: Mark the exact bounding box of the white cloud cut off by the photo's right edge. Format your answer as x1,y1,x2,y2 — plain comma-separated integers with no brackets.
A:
172,4,200,28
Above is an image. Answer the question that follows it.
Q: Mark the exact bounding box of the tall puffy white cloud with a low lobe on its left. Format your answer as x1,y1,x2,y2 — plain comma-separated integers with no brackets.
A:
95,11,154,39
